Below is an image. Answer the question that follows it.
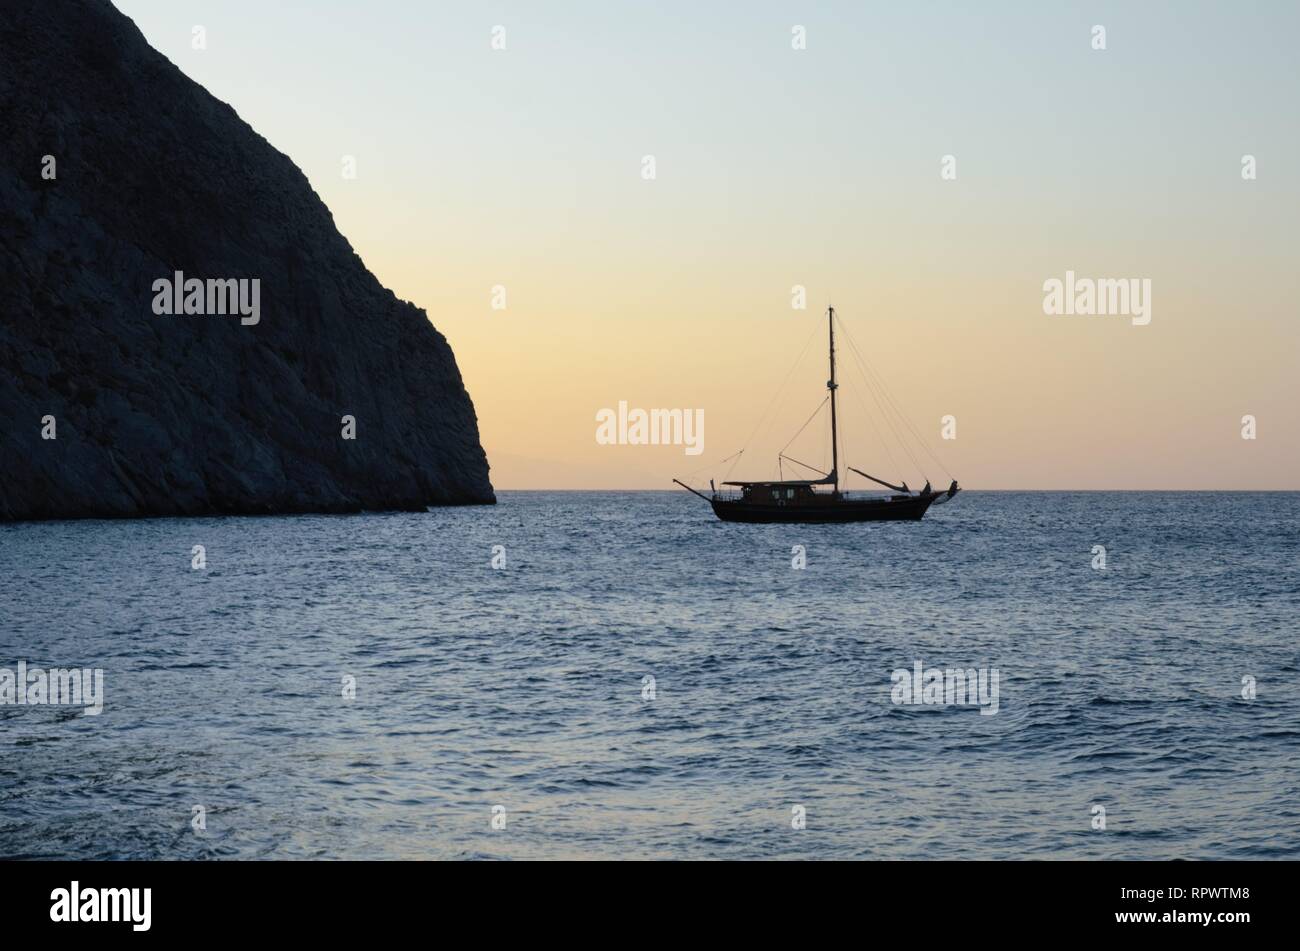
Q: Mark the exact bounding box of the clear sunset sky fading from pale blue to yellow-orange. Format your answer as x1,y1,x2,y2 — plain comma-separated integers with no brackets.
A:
114,0,1300,490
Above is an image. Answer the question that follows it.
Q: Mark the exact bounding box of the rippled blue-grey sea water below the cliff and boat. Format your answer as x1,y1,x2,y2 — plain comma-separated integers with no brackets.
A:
0,492,1300,859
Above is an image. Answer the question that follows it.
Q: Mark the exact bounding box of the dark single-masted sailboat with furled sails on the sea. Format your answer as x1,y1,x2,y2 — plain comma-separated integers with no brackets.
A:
673,307,961,524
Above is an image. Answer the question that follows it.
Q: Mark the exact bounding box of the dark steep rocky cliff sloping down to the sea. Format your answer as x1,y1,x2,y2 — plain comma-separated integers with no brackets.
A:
0,0,494,520
